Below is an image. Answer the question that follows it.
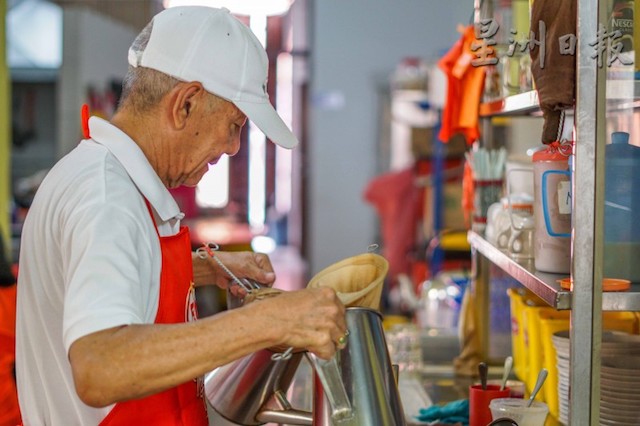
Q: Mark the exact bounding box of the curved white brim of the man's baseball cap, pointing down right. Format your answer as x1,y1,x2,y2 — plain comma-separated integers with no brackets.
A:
233,101,298,149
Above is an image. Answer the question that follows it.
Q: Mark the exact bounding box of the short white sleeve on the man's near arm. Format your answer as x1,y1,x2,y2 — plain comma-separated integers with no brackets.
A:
63,202,160,352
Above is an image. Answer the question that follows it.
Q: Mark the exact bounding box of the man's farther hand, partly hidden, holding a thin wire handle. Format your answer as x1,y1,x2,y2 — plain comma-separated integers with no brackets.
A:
208,251,276,292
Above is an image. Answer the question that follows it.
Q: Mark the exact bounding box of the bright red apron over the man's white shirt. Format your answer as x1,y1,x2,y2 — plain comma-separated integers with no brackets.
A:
100,202,209,426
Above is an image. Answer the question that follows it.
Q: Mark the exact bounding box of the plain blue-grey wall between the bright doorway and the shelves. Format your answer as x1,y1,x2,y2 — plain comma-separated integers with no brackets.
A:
305,0,473,273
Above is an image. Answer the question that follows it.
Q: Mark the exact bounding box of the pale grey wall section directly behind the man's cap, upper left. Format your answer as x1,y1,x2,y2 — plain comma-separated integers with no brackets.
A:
57,7,138,157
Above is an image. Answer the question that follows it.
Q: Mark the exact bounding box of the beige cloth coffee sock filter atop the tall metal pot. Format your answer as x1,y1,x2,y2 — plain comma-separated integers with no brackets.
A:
307,253,389,310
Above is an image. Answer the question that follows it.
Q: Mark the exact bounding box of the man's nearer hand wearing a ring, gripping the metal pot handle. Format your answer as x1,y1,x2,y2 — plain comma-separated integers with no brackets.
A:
251,288,347,359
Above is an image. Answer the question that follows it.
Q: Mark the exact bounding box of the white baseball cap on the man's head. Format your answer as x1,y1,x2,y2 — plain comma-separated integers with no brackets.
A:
129,6,298,148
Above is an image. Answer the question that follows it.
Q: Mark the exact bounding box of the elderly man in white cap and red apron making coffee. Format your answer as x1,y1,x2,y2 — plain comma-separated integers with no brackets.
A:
16,7,346,425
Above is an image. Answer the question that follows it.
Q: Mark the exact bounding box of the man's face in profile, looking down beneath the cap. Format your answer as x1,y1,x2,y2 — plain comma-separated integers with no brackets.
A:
169,99,247,188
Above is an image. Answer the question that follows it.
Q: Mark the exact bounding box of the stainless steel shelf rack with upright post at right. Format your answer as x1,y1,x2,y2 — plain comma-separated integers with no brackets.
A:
468,0,640,425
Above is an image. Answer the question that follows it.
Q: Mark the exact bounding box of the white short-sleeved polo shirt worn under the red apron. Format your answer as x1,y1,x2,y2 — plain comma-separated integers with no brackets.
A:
16,117,183,426
